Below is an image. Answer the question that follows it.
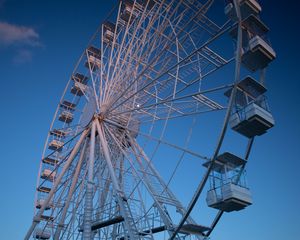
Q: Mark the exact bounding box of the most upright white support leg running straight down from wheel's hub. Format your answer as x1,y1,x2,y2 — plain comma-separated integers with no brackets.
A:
83,121,96,240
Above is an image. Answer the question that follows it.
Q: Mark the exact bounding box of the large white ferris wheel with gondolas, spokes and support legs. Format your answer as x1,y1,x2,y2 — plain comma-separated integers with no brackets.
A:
25,0,276,240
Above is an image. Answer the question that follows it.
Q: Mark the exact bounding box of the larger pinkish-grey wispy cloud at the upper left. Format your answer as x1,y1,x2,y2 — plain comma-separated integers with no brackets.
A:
0,22,41,47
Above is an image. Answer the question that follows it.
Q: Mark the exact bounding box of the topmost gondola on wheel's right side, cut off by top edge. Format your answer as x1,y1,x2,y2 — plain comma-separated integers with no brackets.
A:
224,0,261,20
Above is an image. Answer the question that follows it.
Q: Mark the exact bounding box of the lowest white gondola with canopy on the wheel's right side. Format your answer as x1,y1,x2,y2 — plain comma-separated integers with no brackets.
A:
203,152,252,212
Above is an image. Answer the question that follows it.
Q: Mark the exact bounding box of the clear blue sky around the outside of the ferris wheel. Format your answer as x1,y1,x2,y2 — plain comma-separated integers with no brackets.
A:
0,0,300,240
